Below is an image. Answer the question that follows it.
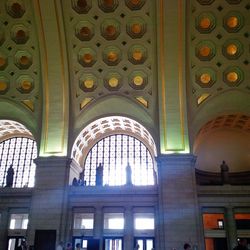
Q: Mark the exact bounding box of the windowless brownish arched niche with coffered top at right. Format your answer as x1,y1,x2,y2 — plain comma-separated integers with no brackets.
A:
193,113,250,172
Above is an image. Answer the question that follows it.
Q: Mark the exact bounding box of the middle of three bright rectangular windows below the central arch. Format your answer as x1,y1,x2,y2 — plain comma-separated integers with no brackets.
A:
104,213,124,229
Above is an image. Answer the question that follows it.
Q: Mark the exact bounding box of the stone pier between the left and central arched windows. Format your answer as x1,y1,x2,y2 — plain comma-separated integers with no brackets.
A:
28,156,71,245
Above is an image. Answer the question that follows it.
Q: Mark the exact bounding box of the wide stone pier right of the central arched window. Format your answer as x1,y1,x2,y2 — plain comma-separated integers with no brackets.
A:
156,154,202,250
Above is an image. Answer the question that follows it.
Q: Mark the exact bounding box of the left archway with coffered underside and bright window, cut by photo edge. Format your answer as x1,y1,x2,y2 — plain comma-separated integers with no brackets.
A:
0,120,37,188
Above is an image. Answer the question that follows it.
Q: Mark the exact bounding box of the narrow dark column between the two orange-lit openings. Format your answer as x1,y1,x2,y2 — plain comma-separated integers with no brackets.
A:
225,206,237,249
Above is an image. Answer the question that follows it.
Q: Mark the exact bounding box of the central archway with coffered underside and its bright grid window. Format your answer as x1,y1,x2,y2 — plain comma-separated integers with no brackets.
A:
72,116,156,185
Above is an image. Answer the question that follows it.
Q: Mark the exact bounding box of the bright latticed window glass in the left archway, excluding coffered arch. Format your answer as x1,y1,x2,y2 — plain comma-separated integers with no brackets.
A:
0,137,37,188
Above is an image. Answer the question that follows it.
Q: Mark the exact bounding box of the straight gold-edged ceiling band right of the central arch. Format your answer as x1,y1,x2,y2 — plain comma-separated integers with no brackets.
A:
157,0,190,154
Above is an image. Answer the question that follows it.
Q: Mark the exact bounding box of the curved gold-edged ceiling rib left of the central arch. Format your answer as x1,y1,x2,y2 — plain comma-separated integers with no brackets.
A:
32,0,69,156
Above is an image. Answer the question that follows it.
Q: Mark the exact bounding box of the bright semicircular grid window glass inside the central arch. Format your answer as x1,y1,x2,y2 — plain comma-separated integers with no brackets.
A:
84,134,155,186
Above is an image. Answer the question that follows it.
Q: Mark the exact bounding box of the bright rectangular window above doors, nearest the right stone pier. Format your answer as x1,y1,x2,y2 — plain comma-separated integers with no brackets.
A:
134,213,155,230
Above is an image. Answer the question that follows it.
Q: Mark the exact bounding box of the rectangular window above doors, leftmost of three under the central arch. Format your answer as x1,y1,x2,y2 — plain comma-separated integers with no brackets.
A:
74,213,94,229
